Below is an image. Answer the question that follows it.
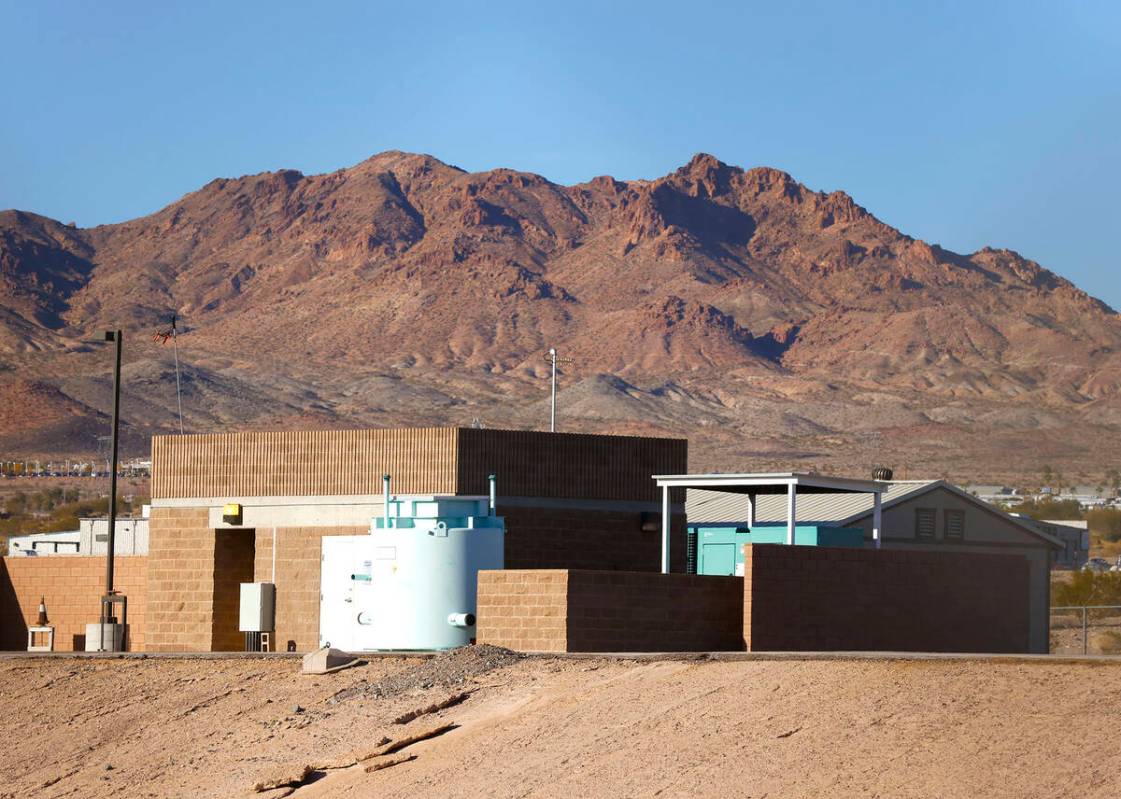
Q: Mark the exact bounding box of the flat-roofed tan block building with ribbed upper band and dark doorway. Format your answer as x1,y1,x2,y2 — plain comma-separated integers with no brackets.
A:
143,427,688,652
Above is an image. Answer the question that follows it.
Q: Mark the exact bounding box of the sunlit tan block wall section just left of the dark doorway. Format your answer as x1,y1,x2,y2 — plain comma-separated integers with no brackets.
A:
146,508,215,652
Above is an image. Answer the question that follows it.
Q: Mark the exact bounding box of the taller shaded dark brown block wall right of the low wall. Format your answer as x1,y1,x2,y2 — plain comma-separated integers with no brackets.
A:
743,545,1030,652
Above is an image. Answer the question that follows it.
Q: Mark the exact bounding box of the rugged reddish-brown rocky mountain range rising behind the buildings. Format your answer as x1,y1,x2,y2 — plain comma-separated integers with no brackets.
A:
0,152,1121,480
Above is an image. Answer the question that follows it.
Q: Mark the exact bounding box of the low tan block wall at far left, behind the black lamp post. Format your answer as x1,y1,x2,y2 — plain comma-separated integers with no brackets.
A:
0,555,148,652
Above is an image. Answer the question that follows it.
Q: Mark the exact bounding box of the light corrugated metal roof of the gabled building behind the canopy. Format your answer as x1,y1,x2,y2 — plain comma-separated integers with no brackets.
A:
685,480,942,524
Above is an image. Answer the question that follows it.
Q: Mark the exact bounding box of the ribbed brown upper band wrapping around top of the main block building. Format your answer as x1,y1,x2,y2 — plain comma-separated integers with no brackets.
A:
151,427,688,501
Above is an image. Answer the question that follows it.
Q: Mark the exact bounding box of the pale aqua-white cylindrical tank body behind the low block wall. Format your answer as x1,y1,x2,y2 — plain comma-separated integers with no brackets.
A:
362,522,504,649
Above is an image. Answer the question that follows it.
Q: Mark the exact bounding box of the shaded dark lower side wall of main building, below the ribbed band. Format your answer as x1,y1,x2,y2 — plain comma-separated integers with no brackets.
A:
498,508,685,572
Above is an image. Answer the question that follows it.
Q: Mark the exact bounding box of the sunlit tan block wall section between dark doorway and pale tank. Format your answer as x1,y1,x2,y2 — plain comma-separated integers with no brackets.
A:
253,527,369,652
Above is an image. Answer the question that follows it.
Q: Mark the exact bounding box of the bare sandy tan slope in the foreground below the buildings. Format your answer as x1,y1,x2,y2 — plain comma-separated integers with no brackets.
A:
0,656,1121,799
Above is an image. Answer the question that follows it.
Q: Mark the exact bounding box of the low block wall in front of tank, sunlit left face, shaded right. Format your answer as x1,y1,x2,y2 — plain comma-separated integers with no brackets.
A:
478,569,743,652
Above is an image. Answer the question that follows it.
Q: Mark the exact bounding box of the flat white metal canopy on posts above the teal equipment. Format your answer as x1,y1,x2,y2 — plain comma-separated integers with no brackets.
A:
654,472,887,574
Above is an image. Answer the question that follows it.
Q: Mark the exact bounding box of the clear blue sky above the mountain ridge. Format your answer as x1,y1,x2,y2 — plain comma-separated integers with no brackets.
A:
0,0,1121,307
